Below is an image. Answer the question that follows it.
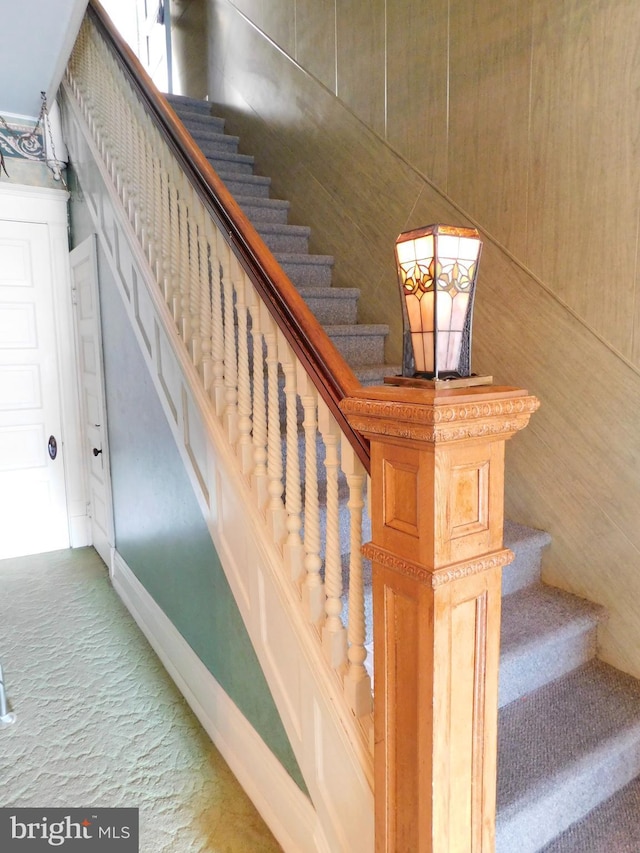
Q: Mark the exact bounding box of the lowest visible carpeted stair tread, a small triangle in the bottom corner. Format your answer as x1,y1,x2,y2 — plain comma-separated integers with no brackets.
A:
541,777,640,853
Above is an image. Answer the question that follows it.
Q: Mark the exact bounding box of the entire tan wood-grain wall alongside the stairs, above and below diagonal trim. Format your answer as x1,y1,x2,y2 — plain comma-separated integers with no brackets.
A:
171,0,640,676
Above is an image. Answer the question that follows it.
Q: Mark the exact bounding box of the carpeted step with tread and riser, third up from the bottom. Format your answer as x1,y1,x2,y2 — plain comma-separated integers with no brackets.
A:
498,584,606,707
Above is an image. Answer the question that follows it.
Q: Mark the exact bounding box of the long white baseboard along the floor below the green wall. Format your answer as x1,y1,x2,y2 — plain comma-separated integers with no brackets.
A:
110,550,329,853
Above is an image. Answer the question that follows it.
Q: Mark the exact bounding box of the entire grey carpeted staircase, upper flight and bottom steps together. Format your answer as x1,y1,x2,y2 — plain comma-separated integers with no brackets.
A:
161,90,640,853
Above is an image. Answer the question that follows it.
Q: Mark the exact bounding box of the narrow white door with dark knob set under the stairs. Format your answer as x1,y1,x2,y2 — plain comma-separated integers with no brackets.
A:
70,236,114,566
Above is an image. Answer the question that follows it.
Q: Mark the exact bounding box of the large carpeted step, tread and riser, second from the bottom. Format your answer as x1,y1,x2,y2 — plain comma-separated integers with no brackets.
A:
496,661,640,853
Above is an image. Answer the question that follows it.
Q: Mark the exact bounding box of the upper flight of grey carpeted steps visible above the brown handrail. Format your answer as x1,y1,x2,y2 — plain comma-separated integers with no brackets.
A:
167,95,400,385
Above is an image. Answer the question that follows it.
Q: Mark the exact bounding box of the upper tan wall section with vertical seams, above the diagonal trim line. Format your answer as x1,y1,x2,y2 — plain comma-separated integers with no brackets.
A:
199,0,640,366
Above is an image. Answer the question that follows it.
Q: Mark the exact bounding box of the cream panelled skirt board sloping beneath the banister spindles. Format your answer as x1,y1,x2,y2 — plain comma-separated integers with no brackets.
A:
62,83,374,853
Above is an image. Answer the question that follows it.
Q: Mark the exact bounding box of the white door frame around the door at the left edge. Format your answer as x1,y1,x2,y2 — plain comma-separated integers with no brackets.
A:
0,182,91,548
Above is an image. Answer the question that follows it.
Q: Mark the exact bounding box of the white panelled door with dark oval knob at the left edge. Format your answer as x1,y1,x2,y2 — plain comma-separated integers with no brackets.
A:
0,219,69,558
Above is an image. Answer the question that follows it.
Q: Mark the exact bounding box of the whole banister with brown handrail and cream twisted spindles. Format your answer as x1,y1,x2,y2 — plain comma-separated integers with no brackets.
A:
64,2,372,740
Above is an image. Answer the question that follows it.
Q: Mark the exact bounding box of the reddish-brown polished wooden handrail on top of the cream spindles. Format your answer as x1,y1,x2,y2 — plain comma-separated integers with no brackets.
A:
88,0,370,471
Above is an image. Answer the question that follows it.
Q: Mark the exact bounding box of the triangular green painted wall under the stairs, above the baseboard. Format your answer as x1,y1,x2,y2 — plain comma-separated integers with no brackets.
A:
72,176,306,791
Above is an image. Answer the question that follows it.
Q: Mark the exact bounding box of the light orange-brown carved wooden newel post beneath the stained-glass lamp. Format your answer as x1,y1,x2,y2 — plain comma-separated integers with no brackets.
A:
342,386,539,853
